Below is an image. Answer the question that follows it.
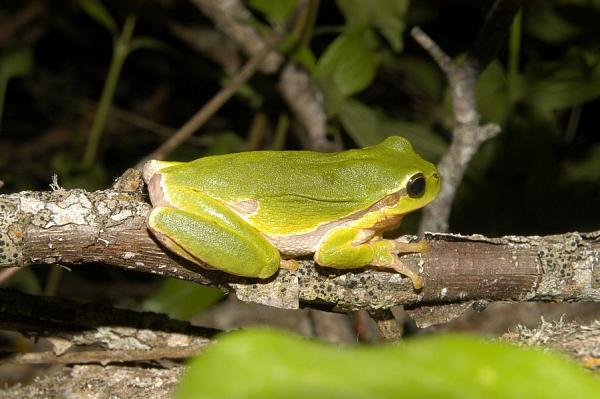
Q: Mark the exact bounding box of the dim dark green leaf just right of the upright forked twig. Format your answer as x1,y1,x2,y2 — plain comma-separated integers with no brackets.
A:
475,61,511,125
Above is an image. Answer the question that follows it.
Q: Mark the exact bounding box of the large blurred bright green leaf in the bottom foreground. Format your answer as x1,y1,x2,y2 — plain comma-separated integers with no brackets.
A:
175,330,600,399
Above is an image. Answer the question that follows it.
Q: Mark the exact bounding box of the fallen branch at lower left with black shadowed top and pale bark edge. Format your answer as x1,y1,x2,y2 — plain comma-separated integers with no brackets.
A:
0,289,219,364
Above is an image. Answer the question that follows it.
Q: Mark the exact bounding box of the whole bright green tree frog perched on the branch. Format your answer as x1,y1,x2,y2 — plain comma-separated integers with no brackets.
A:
144,136,440,288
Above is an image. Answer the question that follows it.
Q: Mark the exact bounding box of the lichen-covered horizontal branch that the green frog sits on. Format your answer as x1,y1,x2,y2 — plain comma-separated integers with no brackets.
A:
0,171,600,311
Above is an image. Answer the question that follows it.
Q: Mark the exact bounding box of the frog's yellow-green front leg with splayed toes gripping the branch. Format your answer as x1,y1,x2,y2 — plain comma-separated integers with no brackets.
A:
315,227,427,289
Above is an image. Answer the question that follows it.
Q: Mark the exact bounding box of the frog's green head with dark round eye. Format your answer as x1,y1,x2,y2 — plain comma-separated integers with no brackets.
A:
375,136,441,219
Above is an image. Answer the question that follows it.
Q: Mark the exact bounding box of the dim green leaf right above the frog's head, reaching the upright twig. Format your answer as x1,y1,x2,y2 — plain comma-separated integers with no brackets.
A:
379,118,448,162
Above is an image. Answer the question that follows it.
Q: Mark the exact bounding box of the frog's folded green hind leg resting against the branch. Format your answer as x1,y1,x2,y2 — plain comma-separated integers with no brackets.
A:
148,187,280,278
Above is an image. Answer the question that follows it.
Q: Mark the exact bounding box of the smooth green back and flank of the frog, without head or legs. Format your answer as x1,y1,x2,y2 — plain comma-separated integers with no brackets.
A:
165,138,426,234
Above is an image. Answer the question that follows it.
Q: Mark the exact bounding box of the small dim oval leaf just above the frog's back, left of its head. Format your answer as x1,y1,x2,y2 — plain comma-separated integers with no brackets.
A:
338,98,384,147
